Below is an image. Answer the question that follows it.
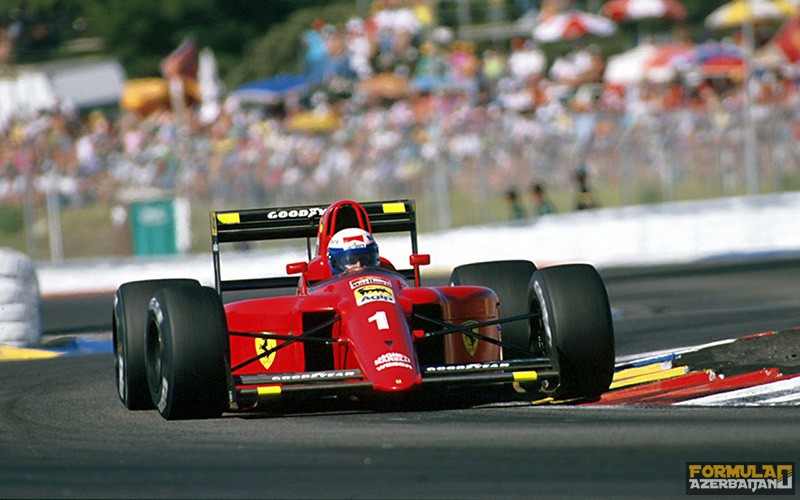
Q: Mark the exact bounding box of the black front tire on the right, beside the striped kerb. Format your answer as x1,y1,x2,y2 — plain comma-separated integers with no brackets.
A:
529,264,614,400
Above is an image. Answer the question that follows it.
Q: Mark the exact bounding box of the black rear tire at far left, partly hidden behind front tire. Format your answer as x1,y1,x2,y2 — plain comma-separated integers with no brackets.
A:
111,279,200,410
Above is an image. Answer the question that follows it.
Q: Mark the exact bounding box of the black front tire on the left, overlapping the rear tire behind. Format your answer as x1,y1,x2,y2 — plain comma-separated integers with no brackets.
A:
145,286,229,420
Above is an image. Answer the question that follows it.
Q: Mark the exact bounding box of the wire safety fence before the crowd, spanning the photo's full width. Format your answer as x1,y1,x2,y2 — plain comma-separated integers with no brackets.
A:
0,95,800,257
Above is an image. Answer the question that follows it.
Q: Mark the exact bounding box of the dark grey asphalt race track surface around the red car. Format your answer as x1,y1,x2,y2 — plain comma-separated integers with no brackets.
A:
0,259,800,498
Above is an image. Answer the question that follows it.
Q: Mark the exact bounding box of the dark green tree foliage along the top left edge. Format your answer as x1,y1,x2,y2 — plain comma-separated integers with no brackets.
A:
0,0,355,85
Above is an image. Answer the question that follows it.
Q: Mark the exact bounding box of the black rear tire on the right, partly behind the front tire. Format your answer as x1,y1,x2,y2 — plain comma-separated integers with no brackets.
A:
450,260,536,359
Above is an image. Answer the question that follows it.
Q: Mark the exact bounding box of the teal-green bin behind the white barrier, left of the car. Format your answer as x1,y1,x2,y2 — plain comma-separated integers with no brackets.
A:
129,199,178,255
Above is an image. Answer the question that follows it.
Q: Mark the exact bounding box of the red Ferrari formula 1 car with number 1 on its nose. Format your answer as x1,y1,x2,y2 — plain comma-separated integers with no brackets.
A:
113,200,614,419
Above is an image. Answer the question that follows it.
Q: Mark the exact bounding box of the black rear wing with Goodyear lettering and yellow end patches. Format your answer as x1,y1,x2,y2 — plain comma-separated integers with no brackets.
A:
210,200,417,293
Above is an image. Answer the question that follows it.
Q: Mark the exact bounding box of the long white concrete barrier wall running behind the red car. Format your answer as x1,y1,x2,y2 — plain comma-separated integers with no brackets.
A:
31,193,800,295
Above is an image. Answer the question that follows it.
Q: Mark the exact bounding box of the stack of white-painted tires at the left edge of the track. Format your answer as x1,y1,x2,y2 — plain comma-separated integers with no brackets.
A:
0,248,42,347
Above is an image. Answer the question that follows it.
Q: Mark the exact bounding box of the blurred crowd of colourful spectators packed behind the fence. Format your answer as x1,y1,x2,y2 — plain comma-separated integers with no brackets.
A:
0,0,800,227
